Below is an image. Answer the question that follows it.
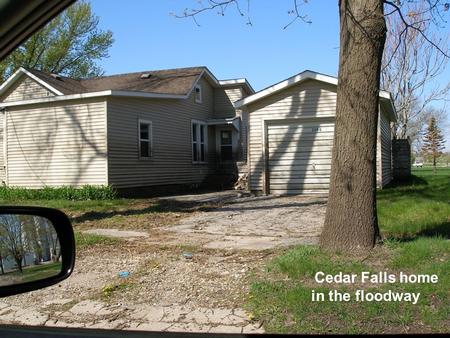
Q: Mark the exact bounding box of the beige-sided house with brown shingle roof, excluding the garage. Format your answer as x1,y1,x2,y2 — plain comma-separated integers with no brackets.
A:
0,67,254,188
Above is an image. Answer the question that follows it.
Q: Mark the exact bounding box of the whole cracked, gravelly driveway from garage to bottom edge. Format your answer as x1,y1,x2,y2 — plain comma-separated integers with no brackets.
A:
0,192,326,333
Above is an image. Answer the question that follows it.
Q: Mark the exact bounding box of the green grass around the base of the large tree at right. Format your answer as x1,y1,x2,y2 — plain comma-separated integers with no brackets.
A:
247,168,450,334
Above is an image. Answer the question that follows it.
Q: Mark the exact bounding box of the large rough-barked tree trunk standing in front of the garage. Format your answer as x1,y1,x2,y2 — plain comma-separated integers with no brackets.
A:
320,0,386,252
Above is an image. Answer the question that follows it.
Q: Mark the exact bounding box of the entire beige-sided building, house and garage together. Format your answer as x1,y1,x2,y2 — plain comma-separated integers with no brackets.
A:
0,67,396,194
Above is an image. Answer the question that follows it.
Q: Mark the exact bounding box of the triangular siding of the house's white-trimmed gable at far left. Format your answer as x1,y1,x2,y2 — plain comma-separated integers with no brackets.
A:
0,75,55,102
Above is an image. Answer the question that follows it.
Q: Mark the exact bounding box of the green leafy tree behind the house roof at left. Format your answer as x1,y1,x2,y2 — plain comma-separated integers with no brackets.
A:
0,1,114,81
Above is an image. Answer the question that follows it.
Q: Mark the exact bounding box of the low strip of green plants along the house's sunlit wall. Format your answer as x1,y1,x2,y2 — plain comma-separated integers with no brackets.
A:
0,185,117,201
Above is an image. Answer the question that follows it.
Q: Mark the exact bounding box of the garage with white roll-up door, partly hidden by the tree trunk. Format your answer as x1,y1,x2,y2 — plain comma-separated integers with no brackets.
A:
234,71,396,194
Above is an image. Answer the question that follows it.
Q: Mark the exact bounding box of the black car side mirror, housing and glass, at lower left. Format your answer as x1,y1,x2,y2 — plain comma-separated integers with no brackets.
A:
0,207,75,297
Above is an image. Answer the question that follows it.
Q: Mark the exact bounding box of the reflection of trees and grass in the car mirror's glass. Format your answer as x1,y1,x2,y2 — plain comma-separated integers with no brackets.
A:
0,214,62,286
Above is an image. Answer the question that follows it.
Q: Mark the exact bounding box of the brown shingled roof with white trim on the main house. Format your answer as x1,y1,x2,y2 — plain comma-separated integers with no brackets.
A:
0,67,254,106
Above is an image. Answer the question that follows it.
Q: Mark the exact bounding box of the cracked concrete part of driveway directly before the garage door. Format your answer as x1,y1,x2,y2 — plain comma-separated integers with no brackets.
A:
164,196,326,250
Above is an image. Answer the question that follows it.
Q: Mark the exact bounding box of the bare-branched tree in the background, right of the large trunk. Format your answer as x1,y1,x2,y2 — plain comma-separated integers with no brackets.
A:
381,1,450,143
